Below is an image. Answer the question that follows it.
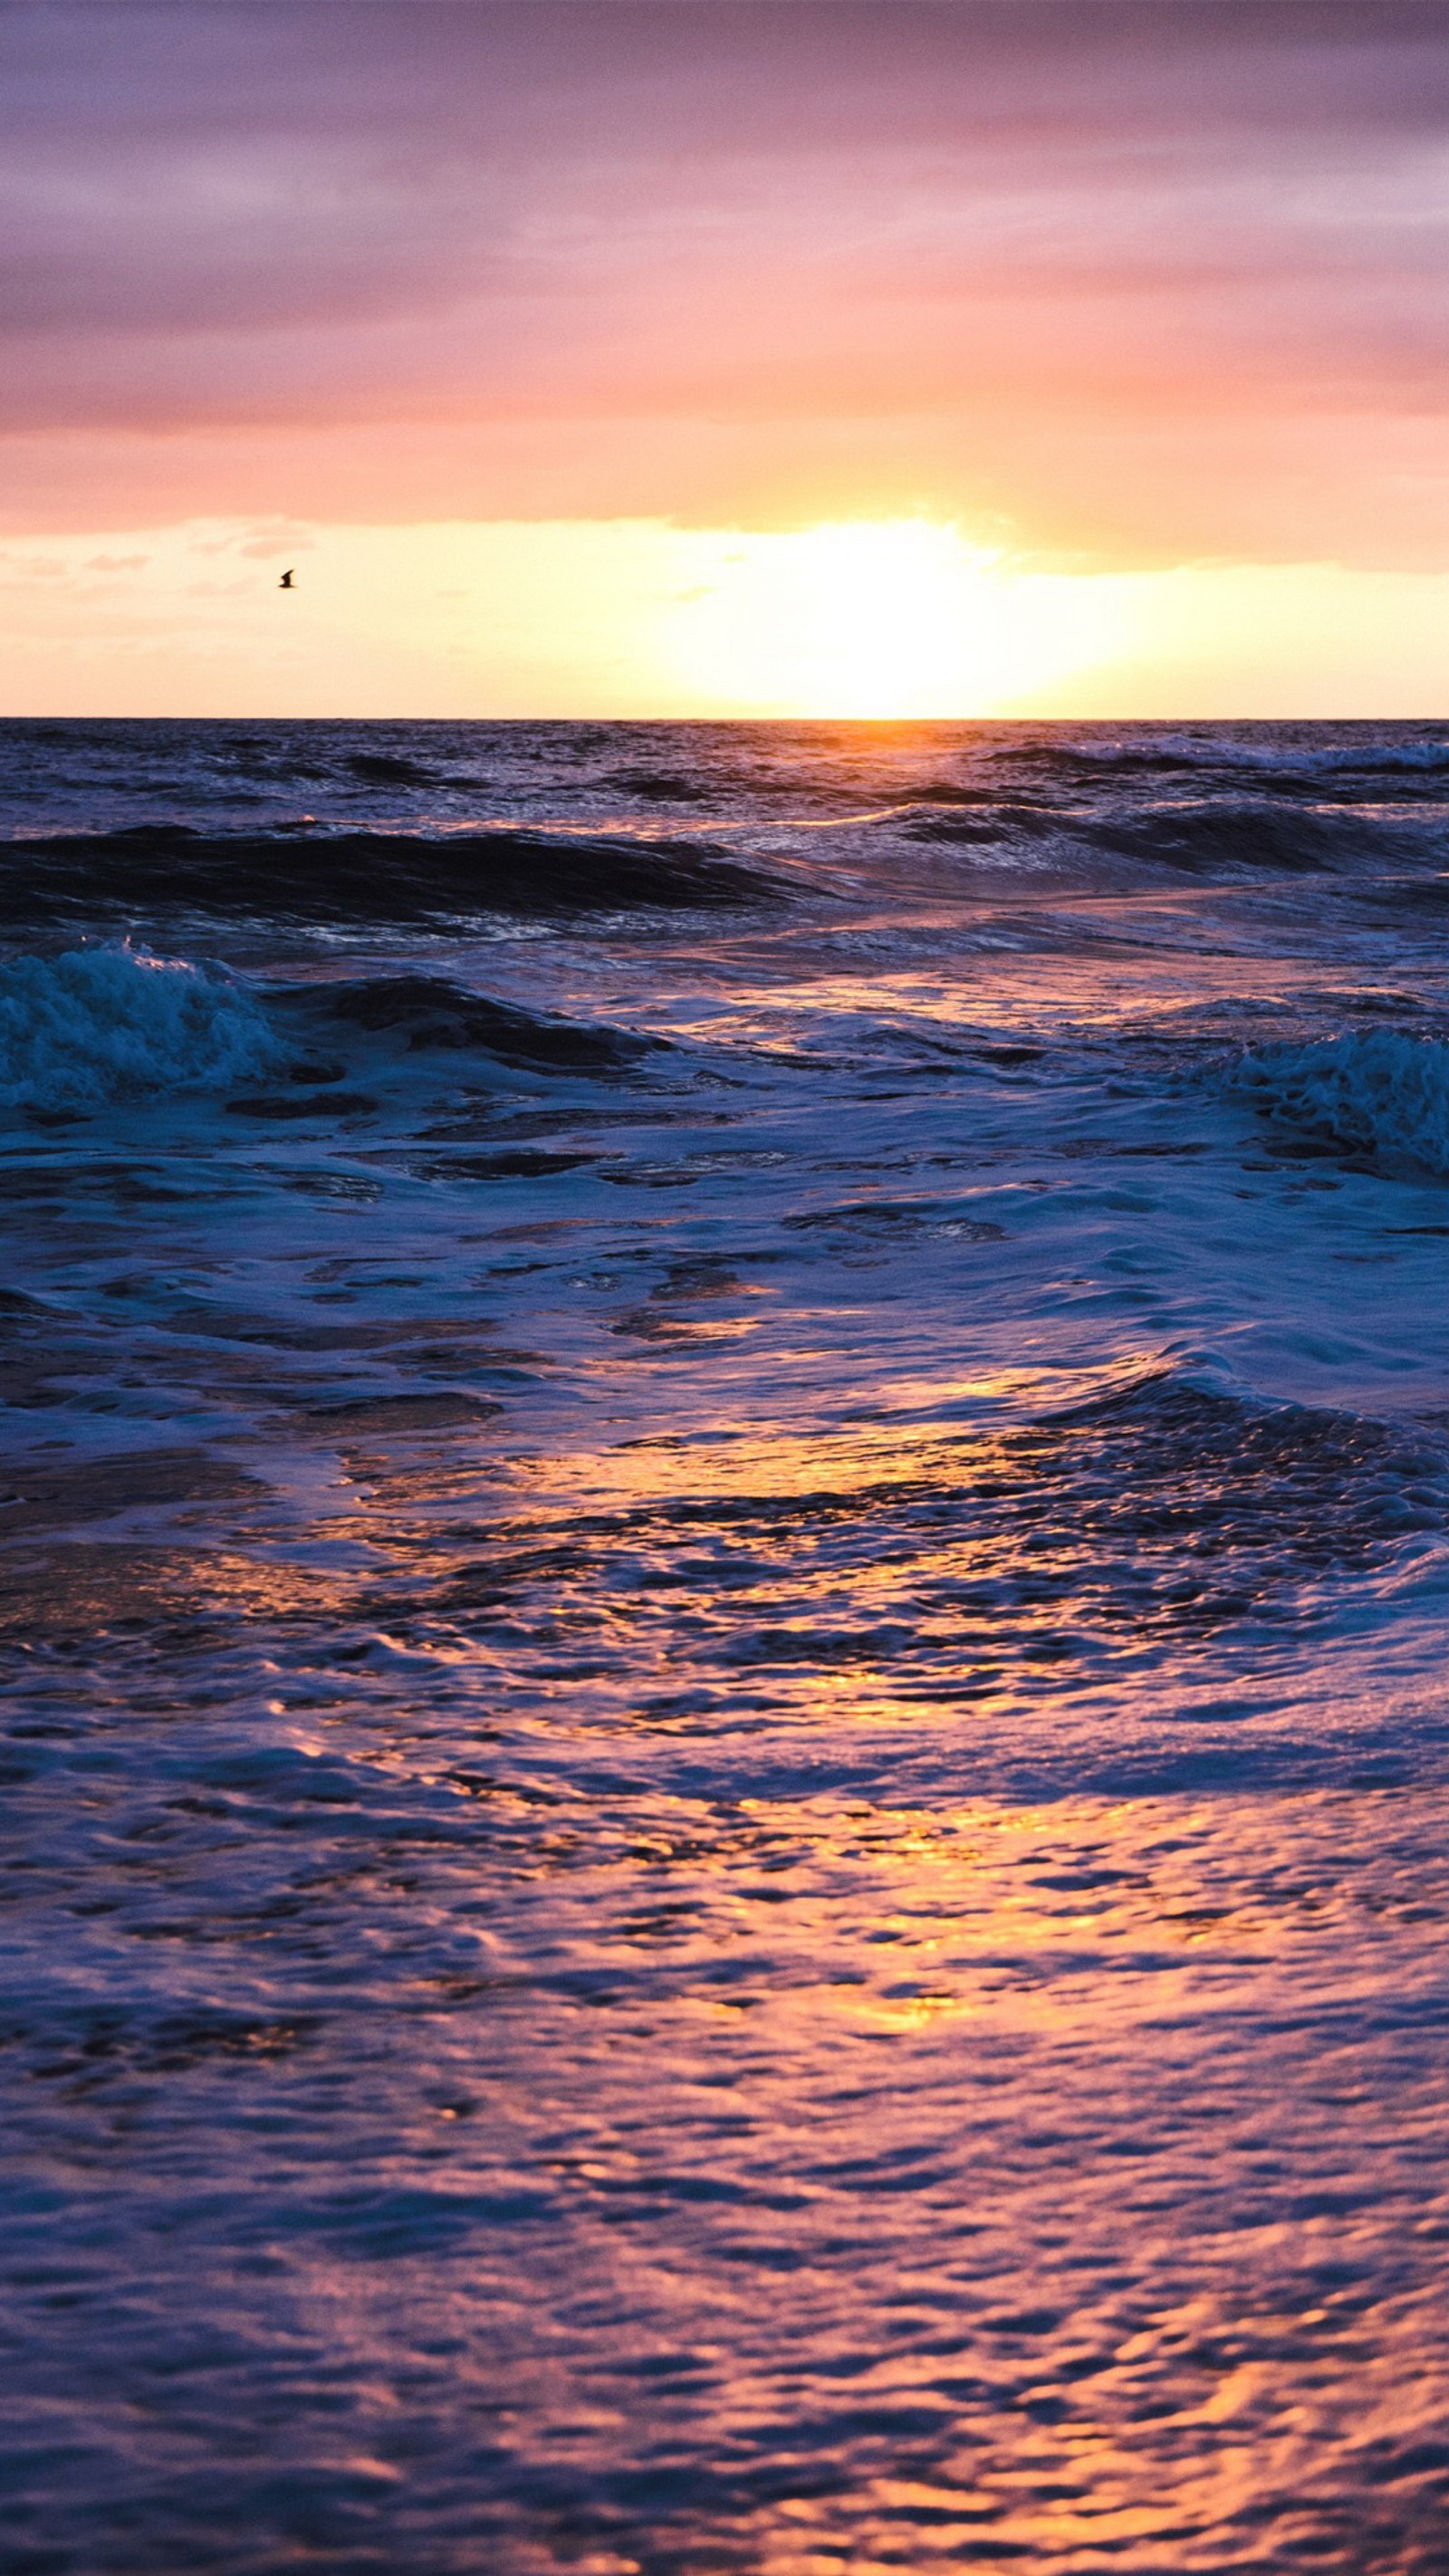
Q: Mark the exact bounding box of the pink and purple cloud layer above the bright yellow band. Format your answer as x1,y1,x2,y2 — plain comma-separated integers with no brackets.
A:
0,0,1449,562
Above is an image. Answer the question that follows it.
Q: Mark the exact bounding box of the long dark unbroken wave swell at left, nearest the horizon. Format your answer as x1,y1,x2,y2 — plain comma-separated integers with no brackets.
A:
0,817,772,925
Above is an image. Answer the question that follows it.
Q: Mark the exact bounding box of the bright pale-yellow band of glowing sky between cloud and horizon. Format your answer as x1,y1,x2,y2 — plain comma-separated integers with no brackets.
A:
0,518,1449,721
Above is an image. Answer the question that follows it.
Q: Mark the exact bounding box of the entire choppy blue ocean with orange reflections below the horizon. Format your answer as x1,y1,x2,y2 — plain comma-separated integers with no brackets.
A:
0,721,1449,2576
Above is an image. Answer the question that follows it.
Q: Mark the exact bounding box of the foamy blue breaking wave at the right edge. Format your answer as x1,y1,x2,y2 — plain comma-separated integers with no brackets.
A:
1233,1028,1449,1177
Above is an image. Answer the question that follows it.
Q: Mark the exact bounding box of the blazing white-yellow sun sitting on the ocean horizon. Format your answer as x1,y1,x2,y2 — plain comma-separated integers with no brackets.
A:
659,518,1122,718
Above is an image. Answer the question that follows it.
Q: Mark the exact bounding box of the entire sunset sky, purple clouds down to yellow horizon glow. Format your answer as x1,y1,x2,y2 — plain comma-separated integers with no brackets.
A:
0,0,1449,716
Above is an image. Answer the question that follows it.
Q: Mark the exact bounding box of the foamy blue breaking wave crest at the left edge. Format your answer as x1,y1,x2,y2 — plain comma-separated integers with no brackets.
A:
0,948,283,1110
